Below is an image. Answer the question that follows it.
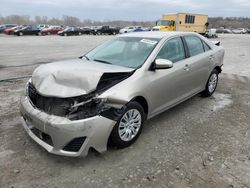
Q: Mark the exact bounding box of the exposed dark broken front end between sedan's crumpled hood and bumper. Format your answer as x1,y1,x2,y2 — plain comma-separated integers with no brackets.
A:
27,71,134,121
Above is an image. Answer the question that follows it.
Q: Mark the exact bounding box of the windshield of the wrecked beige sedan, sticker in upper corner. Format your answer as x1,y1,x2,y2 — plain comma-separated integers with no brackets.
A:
85,37,159,68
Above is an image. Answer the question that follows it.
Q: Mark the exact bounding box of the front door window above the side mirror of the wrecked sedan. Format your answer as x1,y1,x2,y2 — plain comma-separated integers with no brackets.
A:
156,37,185,63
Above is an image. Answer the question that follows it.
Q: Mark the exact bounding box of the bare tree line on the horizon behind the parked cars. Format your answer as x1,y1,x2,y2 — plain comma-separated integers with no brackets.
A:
0,15,250,28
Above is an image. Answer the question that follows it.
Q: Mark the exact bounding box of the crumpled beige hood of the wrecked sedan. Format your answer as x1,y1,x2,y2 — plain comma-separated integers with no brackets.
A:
31,59,134,98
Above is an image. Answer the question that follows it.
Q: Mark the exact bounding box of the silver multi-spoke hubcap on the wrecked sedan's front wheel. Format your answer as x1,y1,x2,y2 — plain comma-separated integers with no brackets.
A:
118,109,142,141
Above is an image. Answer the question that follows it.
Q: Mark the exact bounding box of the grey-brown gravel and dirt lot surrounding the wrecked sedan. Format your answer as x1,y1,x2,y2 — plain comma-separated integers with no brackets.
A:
0,35,250,188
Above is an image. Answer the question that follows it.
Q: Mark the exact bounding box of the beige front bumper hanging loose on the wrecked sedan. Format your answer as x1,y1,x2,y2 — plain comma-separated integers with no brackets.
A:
20,96,116,157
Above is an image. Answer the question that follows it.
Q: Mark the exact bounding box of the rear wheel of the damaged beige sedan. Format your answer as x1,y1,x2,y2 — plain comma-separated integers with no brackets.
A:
202,69,219,97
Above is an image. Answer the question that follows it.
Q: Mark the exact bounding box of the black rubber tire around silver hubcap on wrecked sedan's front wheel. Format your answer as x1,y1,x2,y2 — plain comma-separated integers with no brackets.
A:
110,101,145,148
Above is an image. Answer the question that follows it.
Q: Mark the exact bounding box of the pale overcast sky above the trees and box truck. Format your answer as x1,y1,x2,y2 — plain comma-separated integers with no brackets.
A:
0,0,250,21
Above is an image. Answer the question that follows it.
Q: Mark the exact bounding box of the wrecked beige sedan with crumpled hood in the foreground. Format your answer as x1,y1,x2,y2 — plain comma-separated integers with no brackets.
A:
20,31,224,157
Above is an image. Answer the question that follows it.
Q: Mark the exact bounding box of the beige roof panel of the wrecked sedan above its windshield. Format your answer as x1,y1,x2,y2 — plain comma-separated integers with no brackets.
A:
120,31,197,39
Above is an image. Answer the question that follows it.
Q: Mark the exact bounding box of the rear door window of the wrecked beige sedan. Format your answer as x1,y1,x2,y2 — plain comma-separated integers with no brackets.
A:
185,36,204,57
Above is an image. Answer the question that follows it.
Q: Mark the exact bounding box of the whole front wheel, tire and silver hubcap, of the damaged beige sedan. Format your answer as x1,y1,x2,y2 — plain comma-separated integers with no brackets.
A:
110,102,145,148
